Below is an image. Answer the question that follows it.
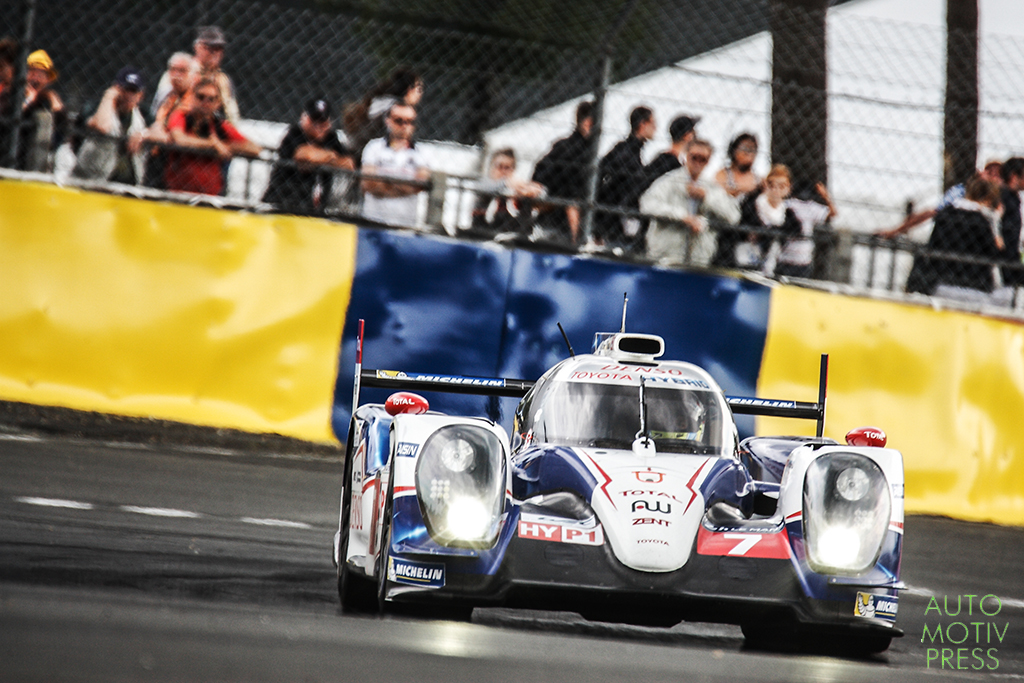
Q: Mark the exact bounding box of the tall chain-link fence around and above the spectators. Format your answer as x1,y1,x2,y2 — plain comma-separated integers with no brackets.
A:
0,0,1024,309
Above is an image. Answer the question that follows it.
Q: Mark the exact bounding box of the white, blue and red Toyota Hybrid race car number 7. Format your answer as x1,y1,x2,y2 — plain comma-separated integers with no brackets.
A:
334,322,903,653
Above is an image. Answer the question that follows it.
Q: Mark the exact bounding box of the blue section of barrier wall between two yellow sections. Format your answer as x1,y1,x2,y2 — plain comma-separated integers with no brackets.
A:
333,228,770,439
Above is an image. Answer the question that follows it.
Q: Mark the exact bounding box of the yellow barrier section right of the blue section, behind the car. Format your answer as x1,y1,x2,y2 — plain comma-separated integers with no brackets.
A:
758,287,1024,524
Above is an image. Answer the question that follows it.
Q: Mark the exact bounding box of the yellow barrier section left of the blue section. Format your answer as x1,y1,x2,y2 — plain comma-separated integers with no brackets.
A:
0,180,357,442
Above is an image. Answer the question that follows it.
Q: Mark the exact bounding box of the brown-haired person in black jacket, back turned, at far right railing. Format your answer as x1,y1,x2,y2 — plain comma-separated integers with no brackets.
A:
906,175,1004,296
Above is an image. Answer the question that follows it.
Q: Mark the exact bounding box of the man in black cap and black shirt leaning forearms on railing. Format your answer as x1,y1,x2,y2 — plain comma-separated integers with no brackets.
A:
263,97,355,215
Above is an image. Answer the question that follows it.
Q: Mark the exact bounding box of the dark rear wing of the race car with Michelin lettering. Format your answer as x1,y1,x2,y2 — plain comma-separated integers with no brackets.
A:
352,317,828,436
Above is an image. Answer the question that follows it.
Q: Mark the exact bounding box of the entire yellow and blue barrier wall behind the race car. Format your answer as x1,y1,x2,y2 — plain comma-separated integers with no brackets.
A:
0,180,1024,525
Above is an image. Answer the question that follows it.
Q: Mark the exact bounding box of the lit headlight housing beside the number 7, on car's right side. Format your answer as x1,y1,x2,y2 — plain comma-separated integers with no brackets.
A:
804,453,892,574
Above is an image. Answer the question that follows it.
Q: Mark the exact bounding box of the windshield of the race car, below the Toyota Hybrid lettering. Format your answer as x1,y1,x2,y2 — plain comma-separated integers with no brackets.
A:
525,382,723,455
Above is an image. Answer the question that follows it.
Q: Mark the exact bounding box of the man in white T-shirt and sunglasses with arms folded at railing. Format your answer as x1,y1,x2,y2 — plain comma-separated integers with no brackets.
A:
360,102,430,227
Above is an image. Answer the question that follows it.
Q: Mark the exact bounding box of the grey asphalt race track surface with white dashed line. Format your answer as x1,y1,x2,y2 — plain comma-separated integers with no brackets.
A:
0,433,1024,683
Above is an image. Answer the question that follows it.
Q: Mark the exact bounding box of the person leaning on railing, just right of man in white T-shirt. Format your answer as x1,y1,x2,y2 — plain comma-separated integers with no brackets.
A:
472,147,545,236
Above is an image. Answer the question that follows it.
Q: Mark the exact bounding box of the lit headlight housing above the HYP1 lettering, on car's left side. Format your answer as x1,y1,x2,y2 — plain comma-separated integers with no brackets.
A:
416,425,505,548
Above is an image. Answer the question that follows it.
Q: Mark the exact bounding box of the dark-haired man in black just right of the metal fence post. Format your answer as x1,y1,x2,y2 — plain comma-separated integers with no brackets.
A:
593,106,657,251
